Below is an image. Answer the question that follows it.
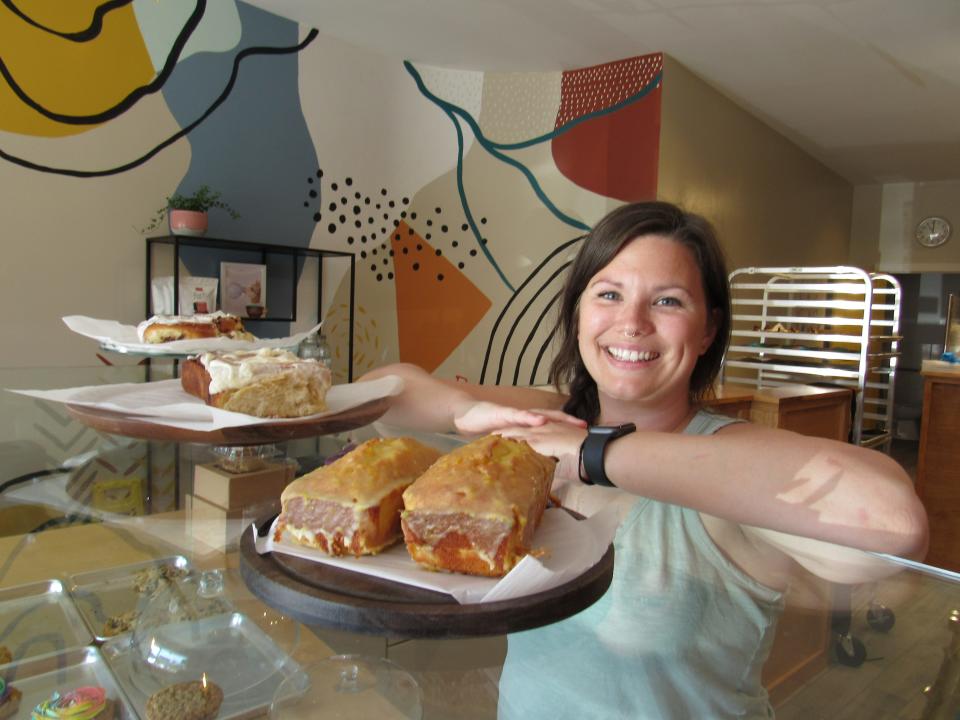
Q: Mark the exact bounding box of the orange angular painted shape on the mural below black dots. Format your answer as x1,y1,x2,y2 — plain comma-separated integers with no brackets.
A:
390,222,492,372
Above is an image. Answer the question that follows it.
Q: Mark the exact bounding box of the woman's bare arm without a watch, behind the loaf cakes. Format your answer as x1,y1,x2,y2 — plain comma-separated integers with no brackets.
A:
360,363,572,434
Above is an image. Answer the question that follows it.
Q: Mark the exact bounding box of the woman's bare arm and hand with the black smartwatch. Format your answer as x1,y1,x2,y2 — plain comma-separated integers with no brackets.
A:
504,423,927,559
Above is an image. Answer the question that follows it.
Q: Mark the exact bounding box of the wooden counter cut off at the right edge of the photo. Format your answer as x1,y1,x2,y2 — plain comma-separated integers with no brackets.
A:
917,360,960,570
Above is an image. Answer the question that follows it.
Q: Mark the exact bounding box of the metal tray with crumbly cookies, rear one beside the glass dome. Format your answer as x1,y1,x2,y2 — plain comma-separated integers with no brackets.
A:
67,555,192,643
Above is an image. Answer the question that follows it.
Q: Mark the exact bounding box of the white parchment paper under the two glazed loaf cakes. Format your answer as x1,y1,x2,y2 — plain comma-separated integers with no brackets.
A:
250,507,620,605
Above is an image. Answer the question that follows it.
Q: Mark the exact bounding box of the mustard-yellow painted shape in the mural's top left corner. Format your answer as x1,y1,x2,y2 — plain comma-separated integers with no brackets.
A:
0,0,154,137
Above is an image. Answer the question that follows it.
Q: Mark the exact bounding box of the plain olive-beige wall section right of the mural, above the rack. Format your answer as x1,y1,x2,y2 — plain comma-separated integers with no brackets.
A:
658,56,853,269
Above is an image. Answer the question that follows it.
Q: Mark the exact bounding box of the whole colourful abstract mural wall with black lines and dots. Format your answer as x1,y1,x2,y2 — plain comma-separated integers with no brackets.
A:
0,0,663,384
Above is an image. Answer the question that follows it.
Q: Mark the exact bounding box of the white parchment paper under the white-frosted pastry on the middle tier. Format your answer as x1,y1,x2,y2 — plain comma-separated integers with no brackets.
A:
10,375,403,432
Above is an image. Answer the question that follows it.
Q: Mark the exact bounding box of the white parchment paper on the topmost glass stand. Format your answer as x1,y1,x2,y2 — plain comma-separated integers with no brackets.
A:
63,315,322,355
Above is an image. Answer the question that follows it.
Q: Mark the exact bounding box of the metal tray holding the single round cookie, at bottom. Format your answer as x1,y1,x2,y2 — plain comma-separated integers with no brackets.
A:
102,613,309,720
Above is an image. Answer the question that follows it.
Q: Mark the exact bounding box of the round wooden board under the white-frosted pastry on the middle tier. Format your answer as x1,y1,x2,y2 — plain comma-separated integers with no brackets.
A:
67,397,392,445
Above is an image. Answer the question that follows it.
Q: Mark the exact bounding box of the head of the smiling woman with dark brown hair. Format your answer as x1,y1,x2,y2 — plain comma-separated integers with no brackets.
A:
551,203,730,434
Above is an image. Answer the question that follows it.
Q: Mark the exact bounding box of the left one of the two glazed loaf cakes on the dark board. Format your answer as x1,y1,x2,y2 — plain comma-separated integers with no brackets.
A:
274,438,440,556
